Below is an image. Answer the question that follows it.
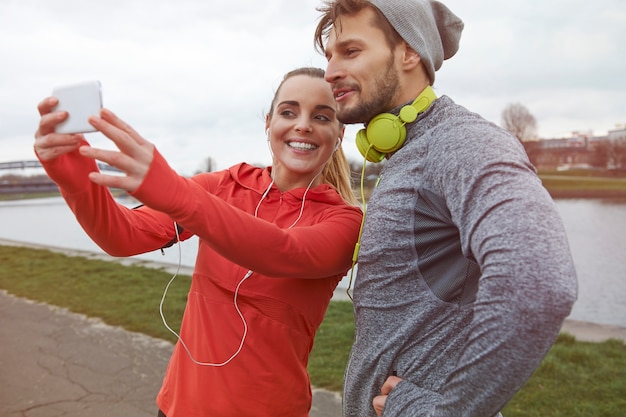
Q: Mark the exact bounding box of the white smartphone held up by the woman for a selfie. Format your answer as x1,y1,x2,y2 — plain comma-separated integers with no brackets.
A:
52,81,102,133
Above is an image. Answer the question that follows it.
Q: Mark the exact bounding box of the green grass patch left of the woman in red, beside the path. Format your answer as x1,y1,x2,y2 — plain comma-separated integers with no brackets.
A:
0,246,191,342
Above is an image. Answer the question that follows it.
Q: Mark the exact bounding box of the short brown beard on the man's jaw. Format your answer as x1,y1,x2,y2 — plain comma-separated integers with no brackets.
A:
337,57,400,124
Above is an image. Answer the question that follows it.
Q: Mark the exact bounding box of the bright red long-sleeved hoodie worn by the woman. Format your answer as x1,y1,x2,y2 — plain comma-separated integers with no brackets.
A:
42,144,361,417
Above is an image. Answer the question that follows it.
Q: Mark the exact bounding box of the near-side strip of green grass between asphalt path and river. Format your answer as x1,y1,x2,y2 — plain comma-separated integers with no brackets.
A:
0,246,626,417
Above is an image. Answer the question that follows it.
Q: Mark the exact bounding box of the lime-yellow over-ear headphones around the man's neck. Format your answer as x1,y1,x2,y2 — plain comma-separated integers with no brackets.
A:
356,86,437,162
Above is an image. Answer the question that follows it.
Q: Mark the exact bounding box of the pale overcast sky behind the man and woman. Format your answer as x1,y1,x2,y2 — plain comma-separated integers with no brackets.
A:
0,0,626,175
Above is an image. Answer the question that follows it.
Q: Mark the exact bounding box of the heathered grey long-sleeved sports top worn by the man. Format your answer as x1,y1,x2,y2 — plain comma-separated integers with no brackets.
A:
344,96,577,417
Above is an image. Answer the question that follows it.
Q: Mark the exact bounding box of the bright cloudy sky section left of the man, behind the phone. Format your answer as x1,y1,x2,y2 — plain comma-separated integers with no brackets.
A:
0,0,324,173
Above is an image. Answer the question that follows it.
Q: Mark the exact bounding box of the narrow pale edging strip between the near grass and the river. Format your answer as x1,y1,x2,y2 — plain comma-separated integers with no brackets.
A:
0,239,626,344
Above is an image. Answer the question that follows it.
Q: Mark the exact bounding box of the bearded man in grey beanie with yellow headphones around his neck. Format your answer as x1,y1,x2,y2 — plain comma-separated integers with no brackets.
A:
315,0,577,417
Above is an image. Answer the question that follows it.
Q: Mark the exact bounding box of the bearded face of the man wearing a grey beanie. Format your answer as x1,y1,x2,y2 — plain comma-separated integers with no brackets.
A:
325,8,400,124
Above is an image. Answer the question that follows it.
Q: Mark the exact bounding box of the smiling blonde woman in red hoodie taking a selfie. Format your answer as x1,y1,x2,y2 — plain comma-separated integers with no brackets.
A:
35,68,361,417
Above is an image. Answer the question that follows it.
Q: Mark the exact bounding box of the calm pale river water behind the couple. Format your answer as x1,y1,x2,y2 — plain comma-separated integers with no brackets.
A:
0,197,626,327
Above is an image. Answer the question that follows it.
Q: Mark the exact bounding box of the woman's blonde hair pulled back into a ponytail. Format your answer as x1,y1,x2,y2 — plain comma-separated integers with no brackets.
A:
268,67,358,205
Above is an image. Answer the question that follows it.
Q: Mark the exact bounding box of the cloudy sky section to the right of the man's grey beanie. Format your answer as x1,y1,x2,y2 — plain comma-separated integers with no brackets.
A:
436,0,626,138
